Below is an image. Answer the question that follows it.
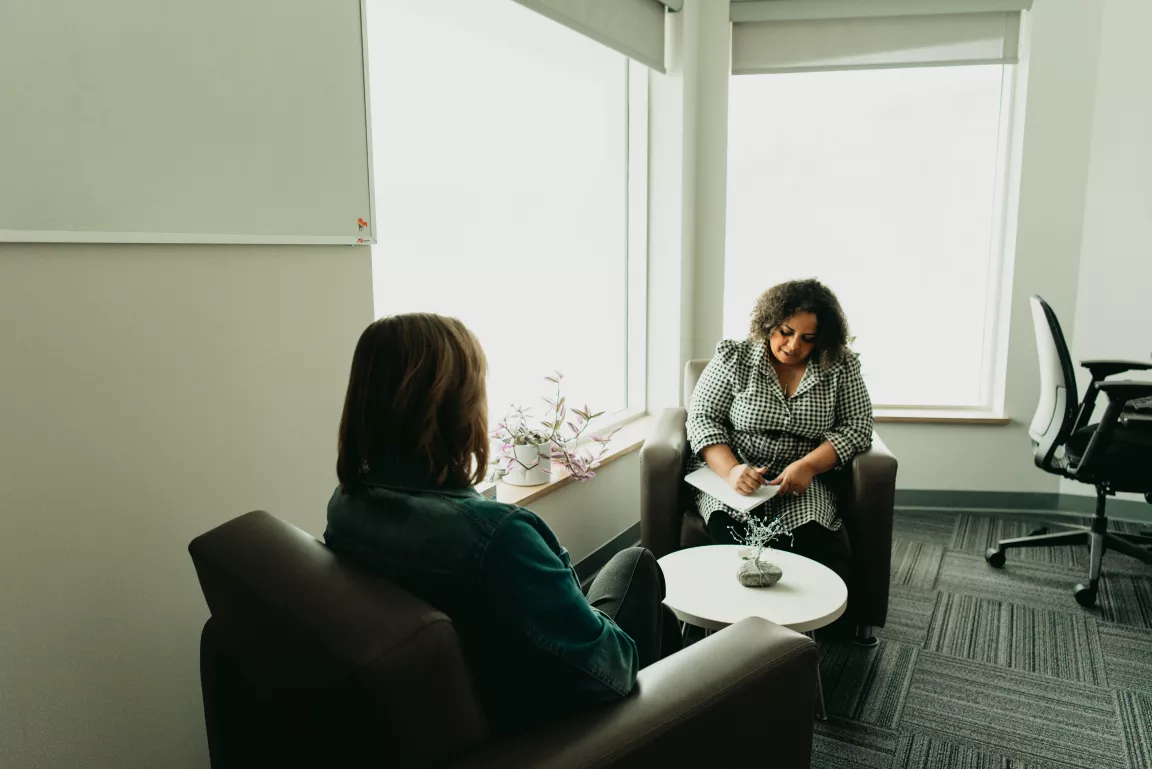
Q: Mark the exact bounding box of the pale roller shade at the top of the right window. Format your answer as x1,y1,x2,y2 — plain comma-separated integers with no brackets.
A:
732,11,1021,75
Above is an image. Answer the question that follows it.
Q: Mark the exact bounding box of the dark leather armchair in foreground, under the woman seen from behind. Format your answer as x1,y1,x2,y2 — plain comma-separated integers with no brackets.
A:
189,512,817,769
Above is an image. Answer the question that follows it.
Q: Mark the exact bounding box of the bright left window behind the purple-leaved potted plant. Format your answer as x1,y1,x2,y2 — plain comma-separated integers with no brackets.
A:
367,0,647,421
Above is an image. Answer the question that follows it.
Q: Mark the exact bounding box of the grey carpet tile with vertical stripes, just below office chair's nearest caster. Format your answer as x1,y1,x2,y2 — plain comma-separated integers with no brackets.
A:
924,594,1107,686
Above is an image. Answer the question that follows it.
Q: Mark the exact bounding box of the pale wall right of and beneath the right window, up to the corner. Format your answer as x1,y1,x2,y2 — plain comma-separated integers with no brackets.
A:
838,0,1105,493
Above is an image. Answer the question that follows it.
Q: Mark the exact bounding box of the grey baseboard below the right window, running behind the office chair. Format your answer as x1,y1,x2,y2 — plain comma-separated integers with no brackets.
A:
896,489,1152,524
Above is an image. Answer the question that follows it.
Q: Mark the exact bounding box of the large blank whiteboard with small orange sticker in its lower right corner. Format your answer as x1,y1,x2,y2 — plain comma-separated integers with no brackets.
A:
0,0,374,244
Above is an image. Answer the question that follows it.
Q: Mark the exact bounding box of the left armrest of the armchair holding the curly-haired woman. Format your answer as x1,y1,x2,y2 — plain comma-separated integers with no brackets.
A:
641,409,688,558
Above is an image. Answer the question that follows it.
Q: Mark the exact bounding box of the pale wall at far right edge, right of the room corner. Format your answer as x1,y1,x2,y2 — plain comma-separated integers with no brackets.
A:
1059,0,1152,500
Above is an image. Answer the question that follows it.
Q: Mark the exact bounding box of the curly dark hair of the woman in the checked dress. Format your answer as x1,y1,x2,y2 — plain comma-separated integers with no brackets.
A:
749,277,851,367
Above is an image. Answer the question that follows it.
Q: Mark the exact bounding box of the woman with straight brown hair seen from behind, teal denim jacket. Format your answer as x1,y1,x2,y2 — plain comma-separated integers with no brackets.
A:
324,314,680,732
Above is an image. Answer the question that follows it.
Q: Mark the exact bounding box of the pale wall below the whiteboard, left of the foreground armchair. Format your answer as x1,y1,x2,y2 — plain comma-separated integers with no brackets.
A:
0,245,372,769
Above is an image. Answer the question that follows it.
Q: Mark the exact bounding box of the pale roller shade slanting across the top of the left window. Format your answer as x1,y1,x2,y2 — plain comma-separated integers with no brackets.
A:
516,0,666,73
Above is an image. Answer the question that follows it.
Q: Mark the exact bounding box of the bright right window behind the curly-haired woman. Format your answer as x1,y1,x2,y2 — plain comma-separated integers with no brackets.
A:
725,63,1014,409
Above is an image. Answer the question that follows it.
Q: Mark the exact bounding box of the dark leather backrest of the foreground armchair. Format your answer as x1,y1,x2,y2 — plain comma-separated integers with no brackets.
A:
189,512,487,768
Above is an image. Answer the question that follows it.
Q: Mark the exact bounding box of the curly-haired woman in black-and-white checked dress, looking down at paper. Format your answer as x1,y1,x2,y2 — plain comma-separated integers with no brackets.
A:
688,280,872,580
